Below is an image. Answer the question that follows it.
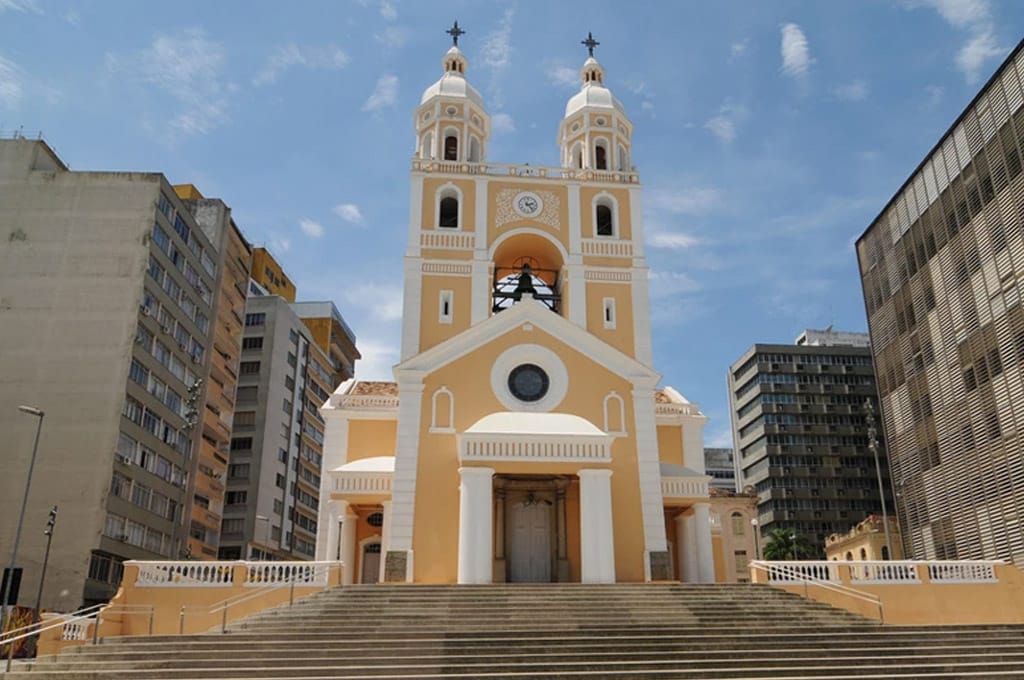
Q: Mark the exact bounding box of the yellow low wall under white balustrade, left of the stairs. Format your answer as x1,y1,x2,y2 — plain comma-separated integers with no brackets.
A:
38,562,344,656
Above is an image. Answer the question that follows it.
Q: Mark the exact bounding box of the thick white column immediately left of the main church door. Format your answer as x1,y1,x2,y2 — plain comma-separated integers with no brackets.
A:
459,467,495,584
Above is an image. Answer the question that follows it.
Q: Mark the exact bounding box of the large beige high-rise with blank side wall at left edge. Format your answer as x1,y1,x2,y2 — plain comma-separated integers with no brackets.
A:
0,139,248,609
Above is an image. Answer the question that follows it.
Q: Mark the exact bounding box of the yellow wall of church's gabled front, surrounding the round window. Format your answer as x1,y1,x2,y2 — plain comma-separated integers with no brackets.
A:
413,328,644,583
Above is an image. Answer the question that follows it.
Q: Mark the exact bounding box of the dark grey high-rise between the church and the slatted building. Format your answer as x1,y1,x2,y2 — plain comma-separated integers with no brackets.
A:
728,329,888,554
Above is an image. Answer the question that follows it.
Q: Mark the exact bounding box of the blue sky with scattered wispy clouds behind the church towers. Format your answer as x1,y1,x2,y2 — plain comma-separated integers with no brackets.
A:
0,0,1024,445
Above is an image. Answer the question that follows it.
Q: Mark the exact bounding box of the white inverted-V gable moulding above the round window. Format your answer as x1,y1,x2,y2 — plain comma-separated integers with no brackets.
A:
394,295,662,389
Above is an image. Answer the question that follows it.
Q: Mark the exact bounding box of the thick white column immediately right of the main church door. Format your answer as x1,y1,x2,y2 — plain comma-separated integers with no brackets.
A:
577,470,615,583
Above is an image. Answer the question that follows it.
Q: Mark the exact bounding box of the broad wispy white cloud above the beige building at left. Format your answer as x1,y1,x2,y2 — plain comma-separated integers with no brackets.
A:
106,29,230,134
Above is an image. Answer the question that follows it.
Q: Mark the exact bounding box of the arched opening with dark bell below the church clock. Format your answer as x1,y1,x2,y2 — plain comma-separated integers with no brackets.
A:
492,233,563,313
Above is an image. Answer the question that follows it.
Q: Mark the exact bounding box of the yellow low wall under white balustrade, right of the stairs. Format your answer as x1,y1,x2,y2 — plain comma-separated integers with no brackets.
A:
751,561,1024,626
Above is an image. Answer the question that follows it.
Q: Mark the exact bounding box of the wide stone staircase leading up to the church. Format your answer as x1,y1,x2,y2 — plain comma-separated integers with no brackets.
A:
16,585,1024,680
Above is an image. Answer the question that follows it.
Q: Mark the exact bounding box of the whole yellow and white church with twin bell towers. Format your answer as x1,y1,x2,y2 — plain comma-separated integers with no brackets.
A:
316,31,716,584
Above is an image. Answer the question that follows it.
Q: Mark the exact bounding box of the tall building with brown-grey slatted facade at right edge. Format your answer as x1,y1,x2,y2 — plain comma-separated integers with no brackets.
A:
857,42,1024,565
